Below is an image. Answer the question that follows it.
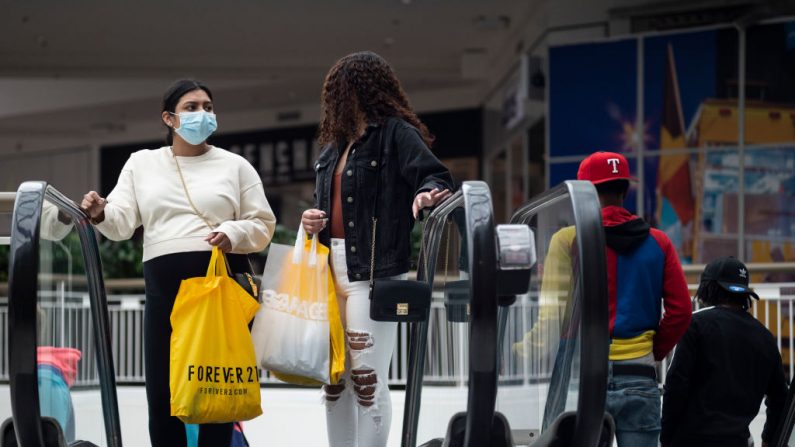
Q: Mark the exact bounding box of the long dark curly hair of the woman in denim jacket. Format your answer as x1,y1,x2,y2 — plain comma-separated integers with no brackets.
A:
318,51,434,147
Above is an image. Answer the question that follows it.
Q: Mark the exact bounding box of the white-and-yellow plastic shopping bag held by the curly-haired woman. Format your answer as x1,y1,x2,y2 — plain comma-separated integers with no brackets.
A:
251,227,345,385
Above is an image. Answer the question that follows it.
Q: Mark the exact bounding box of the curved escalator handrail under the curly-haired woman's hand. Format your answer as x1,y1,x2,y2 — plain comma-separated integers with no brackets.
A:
401,181,504,447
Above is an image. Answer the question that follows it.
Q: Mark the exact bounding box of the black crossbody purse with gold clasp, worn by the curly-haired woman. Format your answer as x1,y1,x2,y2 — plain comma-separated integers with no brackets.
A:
370,125,431,322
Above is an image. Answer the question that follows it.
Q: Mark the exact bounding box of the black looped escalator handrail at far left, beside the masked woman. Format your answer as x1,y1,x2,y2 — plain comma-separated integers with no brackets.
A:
9,182,122,447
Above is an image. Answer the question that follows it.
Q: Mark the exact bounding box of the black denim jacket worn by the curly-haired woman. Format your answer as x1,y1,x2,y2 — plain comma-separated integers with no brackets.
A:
315,118,453,281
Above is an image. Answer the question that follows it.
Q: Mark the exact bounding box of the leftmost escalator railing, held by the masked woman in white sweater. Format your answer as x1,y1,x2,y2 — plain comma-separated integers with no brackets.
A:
9,182,122,447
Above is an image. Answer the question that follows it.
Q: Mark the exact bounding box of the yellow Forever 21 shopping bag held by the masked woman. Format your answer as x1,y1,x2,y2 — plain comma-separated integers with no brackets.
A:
169,247,262,424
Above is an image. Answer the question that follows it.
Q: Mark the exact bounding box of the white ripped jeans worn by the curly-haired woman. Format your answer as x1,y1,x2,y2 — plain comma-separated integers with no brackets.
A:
324,239,407,447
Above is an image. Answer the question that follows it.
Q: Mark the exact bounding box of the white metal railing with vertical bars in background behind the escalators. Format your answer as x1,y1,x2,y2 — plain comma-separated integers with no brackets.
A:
0,283,795,386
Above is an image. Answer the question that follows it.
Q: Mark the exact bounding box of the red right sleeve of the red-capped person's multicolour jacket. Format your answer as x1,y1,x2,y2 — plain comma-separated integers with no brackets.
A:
651,229,693,360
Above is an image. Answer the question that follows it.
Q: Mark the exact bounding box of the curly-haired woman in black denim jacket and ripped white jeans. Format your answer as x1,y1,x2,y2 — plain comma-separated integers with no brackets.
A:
302,51,453,447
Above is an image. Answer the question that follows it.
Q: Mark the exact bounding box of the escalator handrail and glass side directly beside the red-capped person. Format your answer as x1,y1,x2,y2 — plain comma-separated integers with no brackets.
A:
506,181,609,446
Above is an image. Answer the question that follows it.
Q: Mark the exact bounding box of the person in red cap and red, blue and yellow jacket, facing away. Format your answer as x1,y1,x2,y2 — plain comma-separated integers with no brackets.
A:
577,152,692,447
